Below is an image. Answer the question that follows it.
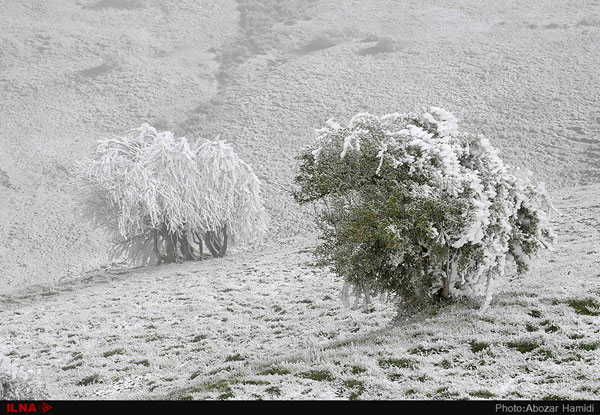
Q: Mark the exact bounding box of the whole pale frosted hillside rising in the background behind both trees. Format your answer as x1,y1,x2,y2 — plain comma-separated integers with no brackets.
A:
0,0,600,289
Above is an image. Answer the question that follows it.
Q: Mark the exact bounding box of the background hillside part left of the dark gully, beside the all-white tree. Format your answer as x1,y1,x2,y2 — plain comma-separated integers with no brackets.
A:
0,0,237,290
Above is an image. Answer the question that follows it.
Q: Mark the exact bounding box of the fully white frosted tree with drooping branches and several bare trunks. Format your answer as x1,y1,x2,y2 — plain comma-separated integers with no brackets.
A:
78,124,267,264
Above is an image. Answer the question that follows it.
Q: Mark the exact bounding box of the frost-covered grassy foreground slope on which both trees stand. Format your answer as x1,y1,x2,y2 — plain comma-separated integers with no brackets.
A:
0,188,600,399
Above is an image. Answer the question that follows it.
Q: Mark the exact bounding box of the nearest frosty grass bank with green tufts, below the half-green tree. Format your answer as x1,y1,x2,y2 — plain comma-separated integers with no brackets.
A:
169,290,600,399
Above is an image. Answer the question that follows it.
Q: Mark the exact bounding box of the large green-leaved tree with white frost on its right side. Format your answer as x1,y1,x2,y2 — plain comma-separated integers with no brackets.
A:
295,107,552,314
